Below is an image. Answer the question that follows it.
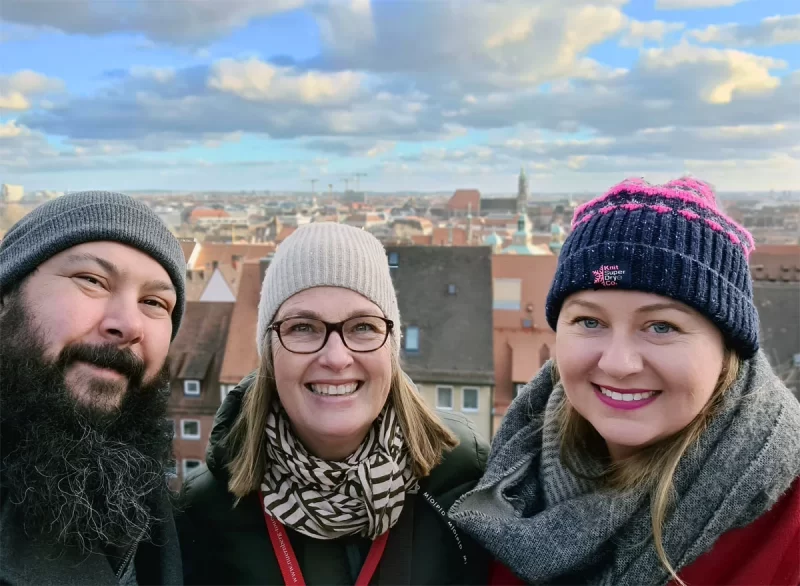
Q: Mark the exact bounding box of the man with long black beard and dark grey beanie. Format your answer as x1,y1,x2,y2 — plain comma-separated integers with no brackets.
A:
0,192,186,585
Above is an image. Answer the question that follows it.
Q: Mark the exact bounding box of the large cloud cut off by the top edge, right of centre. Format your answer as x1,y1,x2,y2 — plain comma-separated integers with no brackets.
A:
309,0,626,90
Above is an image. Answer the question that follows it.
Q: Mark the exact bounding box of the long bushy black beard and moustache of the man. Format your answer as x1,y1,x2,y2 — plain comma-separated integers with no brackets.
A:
0,293,172,553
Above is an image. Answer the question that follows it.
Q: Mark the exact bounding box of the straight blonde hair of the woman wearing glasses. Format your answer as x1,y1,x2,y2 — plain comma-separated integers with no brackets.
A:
225,338,458,502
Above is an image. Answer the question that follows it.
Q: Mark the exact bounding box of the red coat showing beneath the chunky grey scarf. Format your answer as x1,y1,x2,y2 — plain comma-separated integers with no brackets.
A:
490,479,800,586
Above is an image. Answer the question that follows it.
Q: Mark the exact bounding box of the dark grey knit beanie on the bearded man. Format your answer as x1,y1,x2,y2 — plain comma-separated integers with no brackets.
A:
0,191,186,339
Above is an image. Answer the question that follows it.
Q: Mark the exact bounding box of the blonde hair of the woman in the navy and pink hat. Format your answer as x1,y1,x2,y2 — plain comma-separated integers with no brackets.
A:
552,350,741,586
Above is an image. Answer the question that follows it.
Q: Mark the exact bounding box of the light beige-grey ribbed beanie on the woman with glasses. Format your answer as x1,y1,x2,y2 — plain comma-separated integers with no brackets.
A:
256,222,400,356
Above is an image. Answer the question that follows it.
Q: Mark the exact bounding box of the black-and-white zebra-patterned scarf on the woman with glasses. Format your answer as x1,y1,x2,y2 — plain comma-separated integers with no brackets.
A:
261,401,418,539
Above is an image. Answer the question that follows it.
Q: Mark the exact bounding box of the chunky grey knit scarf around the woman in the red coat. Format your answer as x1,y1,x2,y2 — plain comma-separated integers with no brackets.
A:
450,353,800,586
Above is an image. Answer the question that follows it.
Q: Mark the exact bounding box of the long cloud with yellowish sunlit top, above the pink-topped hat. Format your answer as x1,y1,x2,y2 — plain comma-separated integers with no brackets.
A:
453,46,800,138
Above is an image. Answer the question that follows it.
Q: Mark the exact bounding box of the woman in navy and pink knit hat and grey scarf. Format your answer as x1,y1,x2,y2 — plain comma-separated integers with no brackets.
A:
450,179,800,586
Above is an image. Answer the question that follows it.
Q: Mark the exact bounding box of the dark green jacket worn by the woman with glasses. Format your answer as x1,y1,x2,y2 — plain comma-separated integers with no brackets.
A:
177,377,489,585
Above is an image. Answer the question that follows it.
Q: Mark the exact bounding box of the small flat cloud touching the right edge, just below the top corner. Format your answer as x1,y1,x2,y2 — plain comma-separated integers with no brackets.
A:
690,14,800,47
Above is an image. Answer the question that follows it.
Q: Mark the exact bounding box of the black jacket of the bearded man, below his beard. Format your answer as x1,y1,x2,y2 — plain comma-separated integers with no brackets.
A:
0,486,183,586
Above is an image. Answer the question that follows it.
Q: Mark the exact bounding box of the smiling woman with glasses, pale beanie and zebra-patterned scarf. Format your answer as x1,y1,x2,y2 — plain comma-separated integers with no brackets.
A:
179,223,488,585
